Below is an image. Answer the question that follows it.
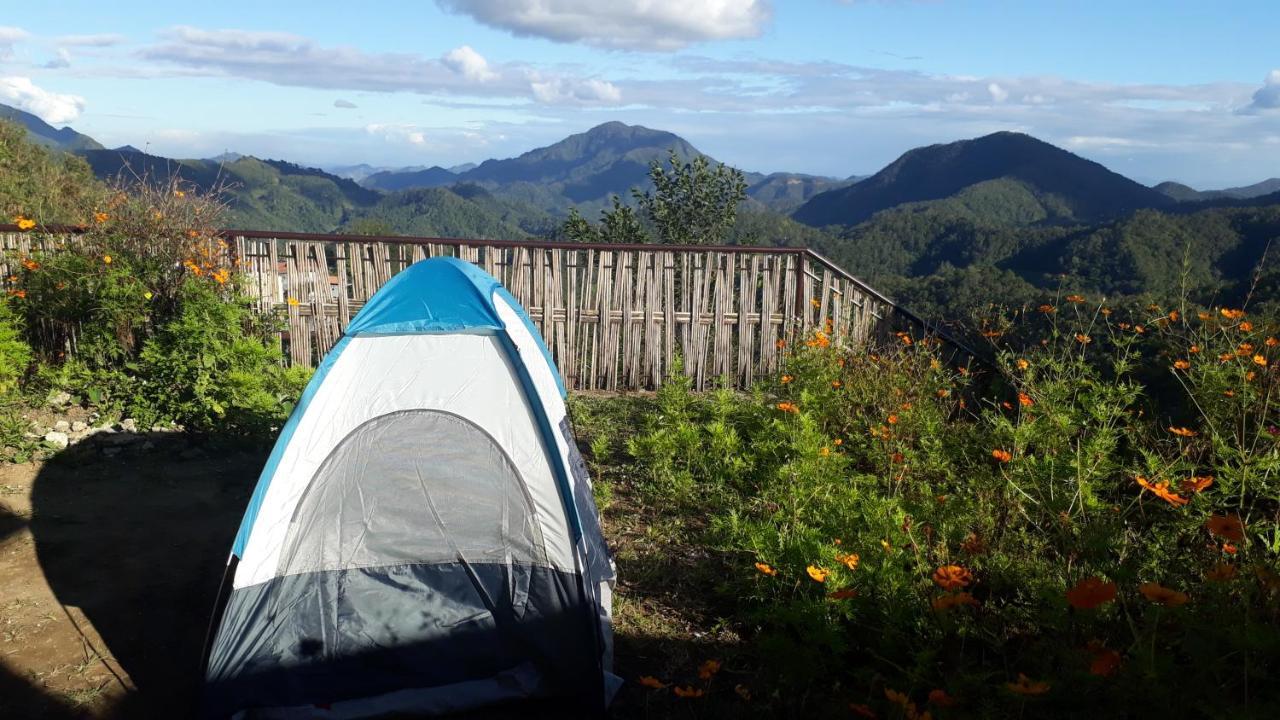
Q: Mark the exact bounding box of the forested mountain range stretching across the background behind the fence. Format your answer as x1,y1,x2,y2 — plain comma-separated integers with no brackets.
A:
10,101,1280,315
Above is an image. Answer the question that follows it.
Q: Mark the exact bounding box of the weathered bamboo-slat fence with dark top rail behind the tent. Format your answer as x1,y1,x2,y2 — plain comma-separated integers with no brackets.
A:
0,225,967,389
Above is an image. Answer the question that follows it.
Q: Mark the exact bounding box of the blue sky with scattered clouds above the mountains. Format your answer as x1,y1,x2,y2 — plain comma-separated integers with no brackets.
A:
0,0,1280,190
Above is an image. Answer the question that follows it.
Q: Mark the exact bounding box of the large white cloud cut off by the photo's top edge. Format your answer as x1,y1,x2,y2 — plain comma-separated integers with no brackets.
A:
436,0,773,51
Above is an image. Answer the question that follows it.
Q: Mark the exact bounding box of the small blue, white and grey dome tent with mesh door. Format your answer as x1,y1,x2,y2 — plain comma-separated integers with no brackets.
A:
204,258,620,717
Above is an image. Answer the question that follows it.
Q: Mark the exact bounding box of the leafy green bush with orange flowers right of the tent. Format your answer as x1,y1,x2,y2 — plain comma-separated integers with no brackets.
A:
623,296,1280,717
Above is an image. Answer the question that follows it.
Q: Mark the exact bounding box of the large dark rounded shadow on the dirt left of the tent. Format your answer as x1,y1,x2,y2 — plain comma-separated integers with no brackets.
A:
29,433,266,717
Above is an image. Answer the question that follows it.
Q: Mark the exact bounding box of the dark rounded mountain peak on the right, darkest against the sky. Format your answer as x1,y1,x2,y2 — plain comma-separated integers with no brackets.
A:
792,132,1174,227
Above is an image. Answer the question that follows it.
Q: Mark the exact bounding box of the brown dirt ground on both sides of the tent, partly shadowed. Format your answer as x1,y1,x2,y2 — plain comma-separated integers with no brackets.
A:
0,425,736,719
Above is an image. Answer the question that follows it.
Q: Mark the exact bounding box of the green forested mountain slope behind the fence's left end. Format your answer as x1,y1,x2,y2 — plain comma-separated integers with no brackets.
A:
81,150,380,232
